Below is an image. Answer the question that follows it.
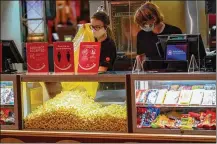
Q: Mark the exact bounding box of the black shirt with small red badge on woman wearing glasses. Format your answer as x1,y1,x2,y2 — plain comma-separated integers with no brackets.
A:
96,37,117,70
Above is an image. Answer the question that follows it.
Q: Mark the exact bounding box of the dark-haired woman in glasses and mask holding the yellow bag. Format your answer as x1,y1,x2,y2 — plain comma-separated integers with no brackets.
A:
90,11,116,72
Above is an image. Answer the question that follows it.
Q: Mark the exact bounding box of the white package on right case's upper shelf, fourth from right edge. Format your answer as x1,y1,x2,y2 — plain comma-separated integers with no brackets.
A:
164,91,180,104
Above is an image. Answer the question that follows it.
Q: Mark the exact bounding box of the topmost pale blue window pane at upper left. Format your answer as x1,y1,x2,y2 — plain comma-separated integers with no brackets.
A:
26,0,43,19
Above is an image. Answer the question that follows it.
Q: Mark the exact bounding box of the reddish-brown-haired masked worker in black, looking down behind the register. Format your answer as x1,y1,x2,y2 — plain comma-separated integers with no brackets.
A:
134,2,182,68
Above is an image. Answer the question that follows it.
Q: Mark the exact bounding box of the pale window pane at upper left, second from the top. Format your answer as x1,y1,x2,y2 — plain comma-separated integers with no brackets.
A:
28,20,44,34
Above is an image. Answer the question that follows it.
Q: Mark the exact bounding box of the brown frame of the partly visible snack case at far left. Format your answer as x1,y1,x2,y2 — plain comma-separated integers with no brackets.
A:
0,74,22,130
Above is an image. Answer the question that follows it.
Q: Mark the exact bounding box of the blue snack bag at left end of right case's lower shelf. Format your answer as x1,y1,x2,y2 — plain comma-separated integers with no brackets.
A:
141,108,160,127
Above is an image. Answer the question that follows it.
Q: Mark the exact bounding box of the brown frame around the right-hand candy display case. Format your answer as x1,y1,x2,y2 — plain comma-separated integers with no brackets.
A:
129,73,216,135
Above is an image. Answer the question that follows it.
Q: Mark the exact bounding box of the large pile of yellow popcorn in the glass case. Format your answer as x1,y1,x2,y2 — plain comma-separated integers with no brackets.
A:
24,91,127,132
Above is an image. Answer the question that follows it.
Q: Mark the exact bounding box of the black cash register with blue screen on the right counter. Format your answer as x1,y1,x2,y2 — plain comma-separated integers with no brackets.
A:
156,34,206,72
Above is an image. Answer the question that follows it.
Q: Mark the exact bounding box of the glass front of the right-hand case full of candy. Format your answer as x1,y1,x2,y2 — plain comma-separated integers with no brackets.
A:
135,80,216,130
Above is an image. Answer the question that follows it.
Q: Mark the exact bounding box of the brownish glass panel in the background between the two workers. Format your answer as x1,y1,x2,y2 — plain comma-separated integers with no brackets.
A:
111,1,142,53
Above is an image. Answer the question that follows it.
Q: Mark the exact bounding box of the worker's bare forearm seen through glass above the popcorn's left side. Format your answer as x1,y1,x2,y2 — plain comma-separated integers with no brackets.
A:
45,82,62,98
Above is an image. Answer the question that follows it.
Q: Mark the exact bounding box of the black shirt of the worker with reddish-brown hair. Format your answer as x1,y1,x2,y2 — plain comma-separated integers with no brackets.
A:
137,24,182,60
